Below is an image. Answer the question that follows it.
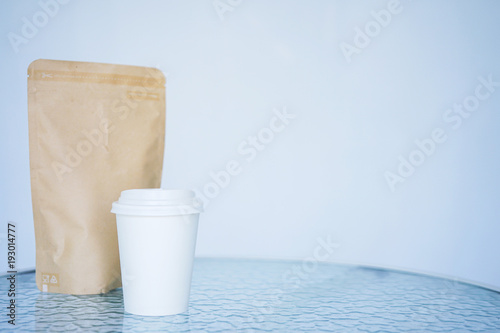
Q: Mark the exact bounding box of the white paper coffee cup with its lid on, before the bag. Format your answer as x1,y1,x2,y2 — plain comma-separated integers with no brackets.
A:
111,189,201,316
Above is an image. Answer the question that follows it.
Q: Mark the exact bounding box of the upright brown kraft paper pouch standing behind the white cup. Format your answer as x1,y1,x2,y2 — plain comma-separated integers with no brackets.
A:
28,60,165,294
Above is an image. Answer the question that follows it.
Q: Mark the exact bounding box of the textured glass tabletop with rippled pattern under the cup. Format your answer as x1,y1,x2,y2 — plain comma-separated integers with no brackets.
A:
0,259,500,332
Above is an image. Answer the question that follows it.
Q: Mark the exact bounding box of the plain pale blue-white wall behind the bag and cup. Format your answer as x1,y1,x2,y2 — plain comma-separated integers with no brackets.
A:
0,0,500,289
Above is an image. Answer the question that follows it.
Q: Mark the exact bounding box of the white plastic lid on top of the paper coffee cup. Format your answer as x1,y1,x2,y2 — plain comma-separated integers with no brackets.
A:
111,188,203,216
